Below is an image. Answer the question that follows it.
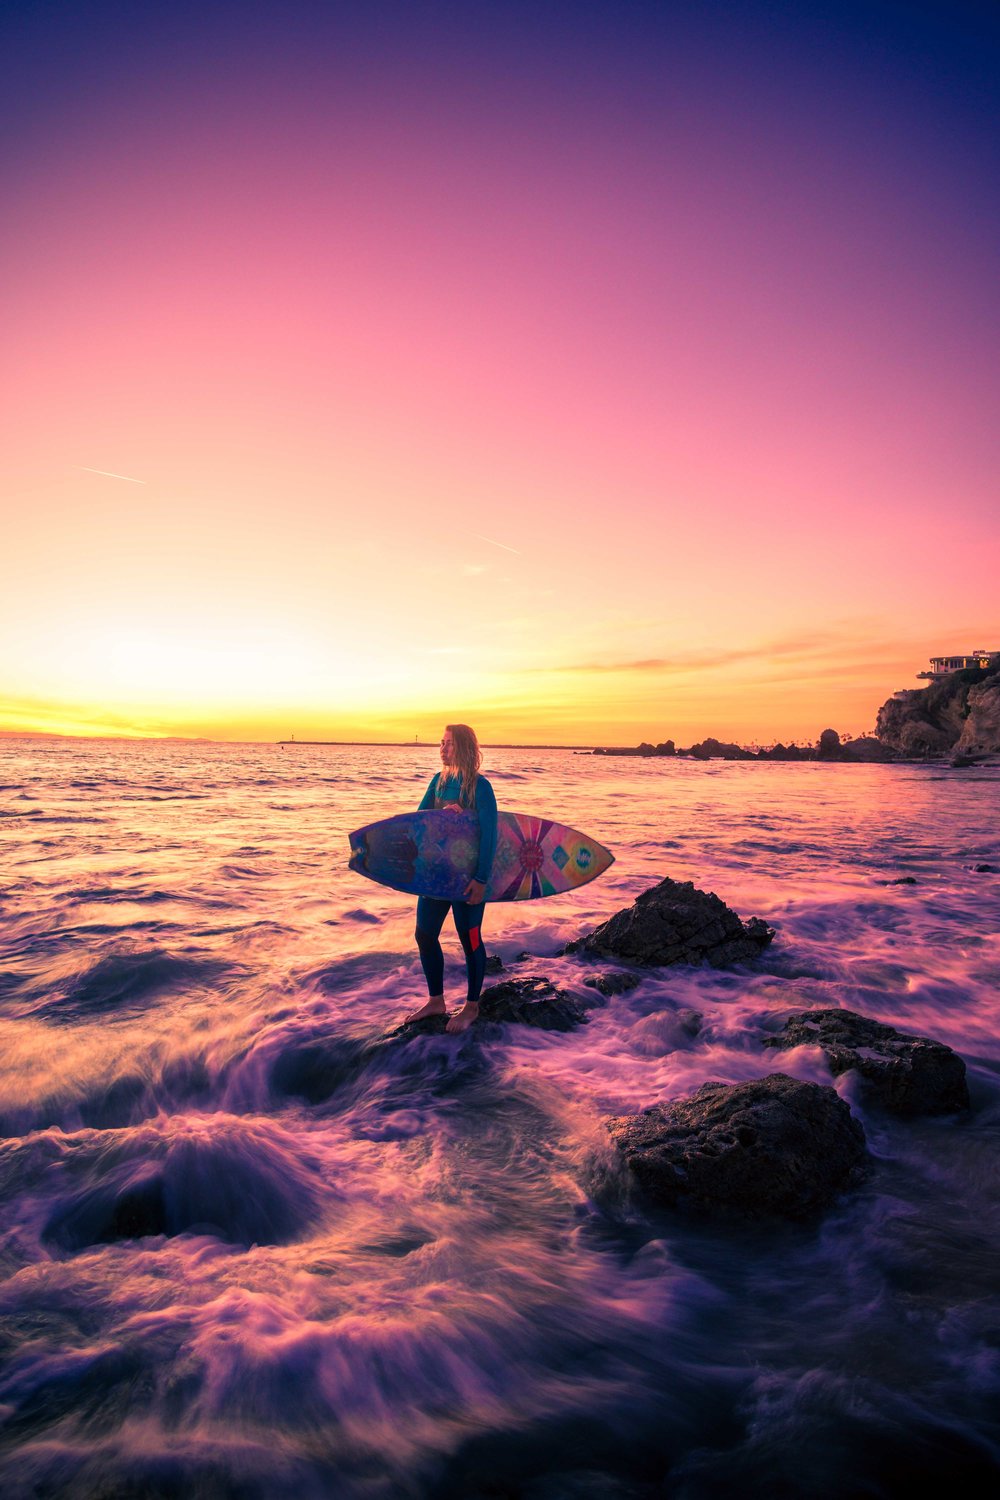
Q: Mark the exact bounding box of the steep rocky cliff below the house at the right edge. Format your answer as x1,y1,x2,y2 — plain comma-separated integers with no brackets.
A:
876,668,1000,756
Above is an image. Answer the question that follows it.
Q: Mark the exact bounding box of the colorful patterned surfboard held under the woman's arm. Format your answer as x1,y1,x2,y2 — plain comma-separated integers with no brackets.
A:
348,810,615,902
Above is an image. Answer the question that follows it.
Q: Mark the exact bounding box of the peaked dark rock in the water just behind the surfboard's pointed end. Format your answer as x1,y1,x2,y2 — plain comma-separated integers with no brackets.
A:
565,878,774,969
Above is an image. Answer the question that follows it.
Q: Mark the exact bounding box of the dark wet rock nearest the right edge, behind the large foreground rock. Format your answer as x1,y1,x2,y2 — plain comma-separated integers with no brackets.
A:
765,1010,969,1115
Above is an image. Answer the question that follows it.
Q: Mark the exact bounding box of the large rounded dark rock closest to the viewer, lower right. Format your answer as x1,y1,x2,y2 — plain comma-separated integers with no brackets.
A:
607,1073,867,1220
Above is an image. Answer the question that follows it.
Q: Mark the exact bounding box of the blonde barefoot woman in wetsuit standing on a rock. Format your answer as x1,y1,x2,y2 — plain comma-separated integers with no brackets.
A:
409,725,496,1032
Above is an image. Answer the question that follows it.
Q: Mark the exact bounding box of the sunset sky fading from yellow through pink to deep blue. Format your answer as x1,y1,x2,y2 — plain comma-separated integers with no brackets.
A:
0,0,1000,746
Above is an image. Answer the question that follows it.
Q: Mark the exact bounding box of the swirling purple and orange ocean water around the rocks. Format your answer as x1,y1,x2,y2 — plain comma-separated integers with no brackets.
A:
0,738,1000,1500
